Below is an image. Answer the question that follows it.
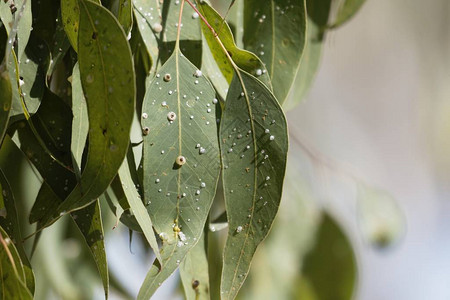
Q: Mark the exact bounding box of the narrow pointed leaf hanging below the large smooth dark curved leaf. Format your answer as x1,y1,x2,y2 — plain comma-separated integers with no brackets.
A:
72,200,109,299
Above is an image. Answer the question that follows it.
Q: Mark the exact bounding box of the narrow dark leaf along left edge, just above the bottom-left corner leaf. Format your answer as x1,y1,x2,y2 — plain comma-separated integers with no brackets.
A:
0,166,34,293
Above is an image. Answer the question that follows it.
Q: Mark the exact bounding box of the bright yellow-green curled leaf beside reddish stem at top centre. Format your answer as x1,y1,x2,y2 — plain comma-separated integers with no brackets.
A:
197,1,272,89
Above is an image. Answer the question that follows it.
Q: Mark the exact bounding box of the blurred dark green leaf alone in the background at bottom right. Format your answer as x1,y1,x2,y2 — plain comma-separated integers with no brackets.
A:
302,214,357,300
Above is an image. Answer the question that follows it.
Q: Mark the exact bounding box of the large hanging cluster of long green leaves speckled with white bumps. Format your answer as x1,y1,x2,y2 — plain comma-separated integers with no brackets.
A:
0,0,370,299
